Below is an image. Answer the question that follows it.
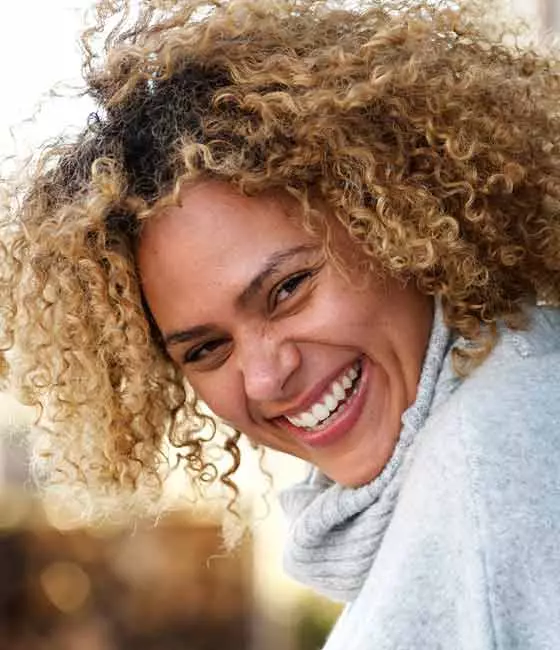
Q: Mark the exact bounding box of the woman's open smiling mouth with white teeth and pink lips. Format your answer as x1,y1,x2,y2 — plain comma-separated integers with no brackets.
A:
278,358,367,447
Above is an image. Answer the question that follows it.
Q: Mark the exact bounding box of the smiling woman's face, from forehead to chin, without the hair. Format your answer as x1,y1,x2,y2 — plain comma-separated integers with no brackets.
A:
138,181,432,486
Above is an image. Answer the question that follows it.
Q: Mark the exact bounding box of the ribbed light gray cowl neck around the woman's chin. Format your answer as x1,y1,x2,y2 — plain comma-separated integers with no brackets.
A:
280,303,454,601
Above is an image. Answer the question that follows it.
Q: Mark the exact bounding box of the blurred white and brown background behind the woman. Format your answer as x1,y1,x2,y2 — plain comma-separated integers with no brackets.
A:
0,0,560,650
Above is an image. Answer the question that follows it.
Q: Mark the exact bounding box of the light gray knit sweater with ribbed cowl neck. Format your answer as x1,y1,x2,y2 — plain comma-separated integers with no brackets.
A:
282,308,560,650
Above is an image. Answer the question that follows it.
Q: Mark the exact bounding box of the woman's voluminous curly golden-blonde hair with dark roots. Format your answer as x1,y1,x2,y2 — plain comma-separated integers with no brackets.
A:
0,0,560,502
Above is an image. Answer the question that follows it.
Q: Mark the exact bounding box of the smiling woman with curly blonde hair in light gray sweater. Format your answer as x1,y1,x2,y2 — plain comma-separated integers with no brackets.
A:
2,0,560,650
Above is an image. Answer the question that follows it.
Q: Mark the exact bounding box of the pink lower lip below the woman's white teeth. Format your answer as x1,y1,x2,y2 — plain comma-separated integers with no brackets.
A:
281,359,370,447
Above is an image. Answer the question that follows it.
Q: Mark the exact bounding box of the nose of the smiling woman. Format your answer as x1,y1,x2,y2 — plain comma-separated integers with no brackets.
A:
238,335,301,402
